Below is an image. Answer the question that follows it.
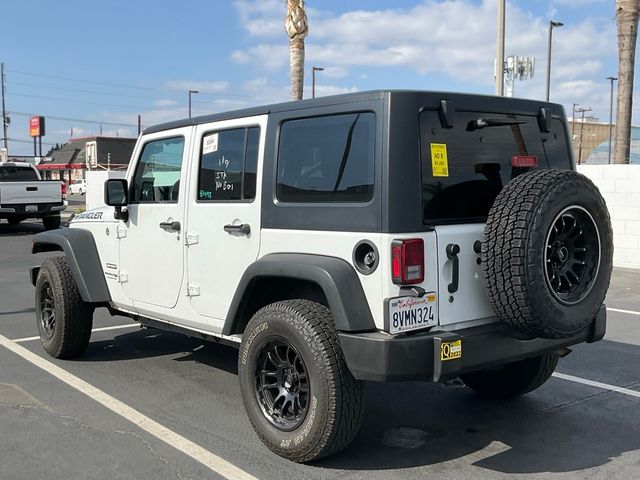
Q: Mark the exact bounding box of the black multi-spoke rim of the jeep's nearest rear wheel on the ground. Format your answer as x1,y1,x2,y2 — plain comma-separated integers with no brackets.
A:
255,338,310,431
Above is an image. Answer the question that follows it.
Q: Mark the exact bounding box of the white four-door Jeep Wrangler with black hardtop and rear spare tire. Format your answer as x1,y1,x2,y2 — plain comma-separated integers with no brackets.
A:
32,91,612,462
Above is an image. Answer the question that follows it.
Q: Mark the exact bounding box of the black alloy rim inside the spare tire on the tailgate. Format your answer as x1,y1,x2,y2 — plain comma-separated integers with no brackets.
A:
544,205,601,305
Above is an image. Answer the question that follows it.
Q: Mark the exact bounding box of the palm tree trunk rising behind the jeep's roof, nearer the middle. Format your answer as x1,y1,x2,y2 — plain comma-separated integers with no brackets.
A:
284,0,309,100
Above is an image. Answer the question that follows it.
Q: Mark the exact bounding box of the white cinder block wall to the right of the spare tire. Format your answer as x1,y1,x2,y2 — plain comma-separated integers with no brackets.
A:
578,165,640,268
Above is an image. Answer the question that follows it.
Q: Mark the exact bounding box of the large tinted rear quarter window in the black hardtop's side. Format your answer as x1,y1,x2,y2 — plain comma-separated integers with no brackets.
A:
276,112,376,202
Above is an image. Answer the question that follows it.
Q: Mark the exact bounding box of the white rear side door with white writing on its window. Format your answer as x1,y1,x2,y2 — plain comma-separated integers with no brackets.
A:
185,117,266,331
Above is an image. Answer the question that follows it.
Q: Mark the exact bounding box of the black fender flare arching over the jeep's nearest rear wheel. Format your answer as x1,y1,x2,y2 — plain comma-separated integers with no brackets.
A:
222,253,376,335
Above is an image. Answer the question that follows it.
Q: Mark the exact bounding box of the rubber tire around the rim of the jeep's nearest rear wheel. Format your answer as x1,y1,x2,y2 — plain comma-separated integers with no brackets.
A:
238,300,363,462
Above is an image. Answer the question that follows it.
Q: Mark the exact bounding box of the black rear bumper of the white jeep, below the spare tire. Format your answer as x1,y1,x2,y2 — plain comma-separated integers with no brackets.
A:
339,305,607,382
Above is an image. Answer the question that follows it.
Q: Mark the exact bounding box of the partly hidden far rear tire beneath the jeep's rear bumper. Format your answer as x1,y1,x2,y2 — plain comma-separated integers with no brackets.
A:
460,353,558,398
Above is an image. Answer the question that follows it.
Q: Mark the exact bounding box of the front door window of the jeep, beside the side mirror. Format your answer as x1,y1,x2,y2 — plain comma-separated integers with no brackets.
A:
131,137,184,203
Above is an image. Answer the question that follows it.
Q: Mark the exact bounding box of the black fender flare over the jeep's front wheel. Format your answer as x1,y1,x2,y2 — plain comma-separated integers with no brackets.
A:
31,228,111,303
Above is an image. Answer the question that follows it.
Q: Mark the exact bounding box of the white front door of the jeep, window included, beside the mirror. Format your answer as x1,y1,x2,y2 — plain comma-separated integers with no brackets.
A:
118,127,192,311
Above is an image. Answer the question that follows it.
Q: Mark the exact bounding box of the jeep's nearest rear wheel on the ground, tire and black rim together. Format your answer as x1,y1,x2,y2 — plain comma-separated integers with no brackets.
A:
238,300,363,462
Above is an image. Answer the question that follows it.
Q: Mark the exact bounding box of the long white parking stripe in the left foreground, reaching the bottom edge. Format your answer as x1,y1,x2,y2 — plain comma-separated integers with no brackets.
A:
0,335,257,480
